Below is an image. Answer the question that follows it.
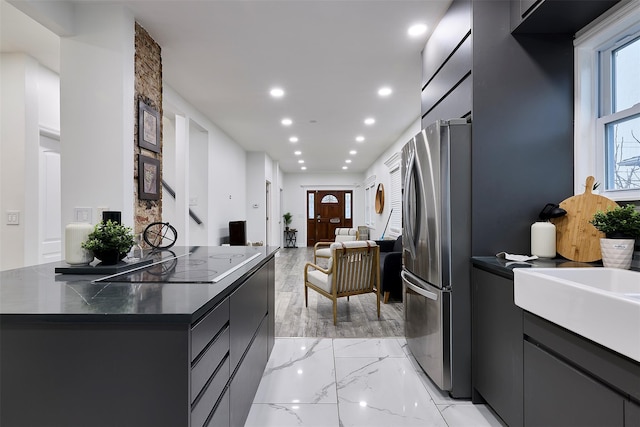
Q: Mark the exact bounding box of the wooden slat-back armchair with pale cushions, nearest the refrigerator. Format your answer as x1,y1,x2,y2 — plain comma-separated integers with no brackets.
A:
304,240,380,325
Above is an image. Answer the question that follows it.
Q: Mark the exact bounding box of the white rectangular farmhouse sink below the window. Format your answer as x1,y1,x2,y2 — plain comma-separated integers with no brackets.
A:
513,268,640,362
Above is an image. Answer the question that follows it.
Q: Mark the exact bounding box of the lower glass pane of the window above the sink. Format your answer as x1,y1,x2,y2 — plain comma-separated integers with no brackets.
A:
605,114,640,190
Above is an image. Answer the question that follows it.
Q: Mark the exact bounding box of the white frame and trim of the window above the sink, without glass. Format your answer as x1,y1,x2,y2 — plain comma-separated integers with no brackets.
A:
573,1,640,201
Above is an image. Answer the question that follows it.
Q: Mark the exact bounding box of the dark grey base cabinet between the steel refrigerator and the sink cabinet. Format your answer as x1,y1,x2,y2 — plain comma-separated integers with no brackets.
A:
471,267,523,427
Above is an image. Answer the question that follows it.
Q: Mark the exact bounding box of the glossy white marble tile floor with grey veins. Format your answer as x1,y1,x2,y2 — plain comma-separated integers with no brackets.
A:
245,337,504,427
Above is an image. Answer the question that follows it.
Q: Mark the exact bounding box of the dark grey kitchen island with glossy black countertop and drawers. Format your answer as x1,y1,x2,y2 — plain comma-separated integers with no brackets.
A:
0,246,278,427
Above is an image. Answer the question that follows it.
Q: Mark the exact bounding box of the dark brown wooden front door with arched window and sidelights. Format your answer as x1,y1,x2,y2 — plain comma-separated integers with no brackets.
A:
307,190,353,246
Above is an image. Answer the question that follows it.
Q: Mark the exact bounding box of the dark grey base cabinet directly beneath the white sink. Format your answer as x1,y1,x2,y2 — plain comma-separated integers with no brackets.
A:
523,312,640,427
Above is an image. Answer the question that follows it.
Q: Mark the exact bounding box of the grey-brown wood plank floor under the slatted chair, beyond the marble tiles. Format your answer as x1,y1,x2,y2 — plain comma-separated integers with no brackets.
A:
275,247,404,338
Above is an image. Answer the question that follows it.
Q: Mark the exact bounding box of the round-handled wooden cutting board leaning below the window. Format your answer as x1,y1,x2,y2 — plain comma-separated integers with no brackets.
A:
551,176,618,262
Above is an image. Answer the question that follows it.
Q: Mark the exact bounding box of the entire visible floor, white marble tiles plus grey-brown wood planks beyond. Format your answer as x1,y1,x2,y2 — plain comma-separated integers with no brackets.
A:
245,248,503,427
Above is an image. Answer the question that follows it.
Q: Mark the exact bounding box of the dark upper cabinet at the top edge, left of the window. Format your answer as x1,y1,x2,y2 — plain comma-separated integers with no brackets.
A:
511,0,619,34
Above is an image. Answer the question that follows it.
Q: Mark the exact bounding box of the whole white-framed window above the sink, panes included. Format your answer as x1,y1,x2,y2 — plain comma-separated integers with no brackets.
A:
574,2,640,201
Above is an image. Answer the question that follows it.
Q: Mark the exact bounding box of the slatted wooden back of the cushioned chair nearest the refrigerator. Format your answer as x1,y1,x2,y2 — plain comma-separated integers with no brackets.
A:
330,240,380,297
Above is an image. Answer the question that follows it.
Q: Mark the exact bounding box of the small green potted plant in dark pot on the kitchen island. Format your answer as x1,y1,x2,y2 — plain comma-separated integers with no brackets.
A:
82,219,135,265
